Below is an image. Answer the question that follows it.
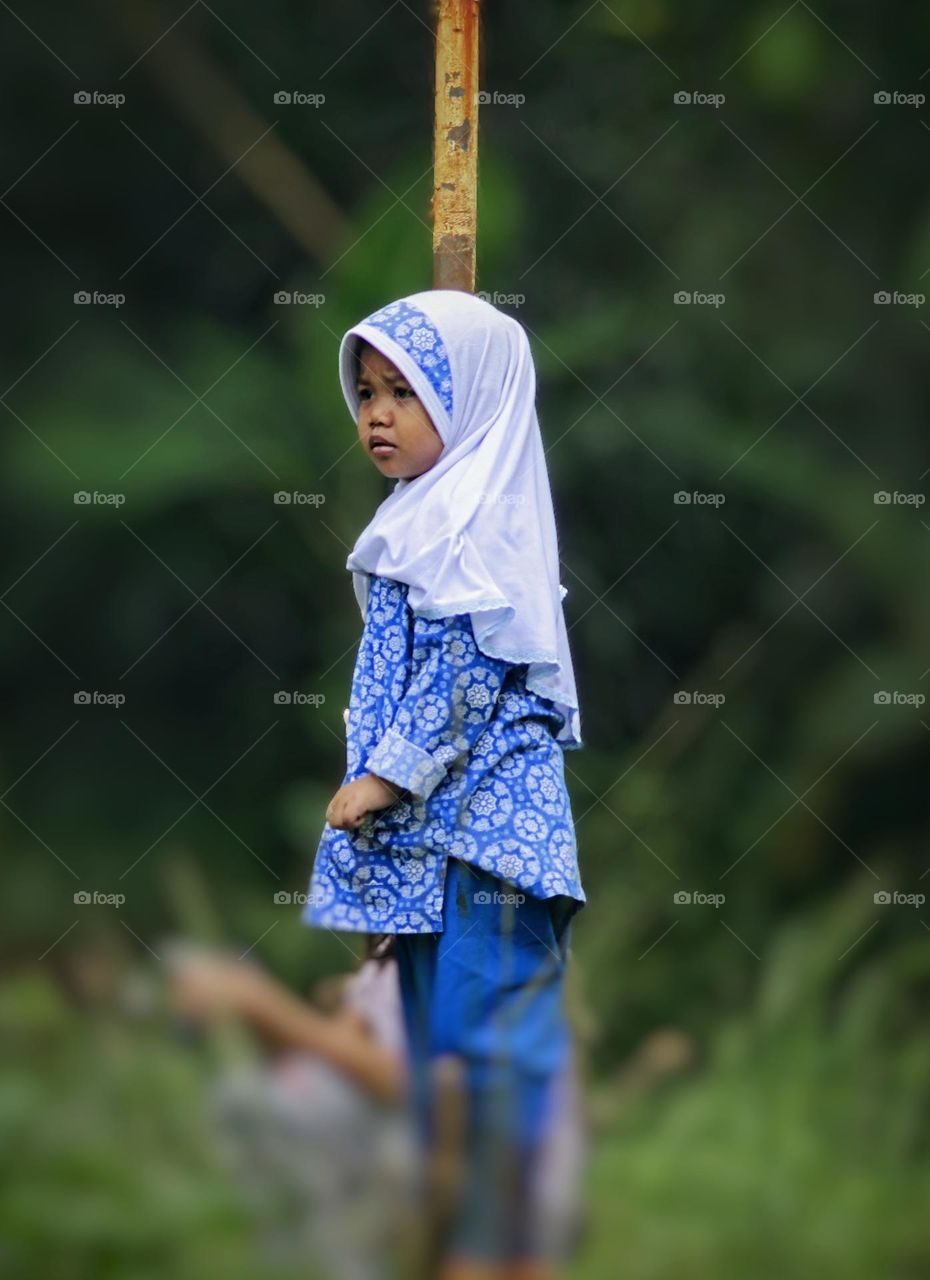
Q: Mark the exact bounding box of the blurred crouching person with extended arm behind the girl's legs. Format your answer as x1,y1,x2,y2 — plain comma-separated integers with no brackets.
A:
165,937,586,1280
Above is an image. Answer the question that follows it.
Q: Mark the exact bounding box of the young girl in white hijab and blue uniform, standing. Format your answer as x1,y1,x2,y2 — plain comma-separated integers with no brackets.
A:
303,289,585,1280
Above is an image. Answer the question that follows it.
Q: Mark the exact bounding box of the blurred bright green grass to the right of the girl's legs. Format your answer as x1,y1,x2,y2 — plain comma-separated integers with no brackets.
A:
572,884,930,1280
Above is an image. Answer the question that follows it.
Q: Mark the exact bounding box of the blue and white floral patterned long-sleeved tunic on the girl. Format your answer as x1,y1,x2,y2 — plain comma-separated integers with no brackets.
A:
302,575,586,933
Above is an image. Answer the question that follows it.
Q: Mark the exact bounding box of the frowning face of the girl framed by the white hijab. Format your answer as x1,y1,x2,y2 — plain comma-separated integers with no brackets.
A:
357,343,443,480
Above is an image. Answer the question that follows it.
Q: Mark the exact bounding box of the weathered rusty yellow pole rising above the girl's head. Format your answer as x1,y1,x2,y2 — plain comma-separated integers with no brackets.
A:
432,0,480,293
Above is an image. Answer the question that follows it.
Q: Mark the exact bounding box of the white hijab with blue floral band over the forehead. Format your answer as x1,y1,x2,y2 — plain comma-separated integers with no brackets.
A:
339,289,582,749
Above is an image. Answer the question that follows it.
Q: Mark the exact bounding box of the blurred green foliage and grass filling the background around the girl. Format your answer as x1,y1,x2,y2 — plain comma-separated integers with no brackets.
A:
0,0,930,1280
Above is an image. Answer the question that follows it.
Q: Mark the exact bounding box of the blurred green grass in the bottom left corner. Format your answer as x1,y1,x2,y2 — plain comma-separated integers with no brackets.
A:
0,975,314,1280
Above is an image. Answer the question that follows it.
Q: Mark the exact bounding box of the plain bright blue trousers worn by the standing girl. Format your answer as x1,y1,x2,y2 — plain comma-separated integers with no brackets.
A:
394,858,578,1260
